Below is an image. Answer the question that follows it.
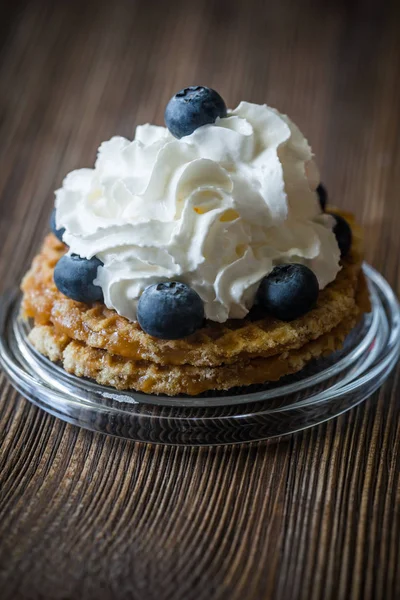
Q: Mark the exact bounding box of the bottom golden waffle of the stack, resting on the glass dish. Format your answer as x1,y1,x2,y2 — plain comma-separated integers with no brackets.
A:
29,274,369,396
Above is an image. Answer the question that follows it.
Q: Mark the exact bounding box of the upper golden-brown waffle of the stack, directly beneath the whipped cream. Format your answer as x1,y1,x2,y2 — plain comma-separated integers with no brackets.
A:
22,214,363,368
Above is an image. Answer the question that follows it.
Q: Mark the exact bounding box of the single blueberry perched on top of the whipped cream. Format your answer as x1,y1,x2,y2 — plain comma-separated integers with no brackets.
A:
164,85,227,139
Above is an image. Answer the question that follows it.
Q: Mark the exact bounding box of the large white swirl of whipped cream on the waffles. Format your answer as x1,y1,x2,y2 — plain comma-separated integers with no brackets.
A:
56,102,340,322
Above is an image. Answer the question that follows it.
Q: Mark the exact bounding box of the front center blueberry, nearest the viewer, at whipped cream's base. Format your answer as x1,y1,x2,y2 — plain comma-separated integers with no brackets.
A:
137,281,204,340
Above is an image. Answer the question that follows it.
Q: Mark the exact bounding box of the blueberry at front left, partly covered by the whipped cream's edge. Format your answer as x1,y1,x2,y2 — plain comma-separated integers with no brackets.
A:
54,254,103,304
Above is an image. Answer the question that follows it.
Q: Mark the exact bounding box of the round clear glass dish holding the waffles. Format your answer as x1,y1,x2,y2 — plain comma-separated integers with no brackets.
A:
0,265,400,445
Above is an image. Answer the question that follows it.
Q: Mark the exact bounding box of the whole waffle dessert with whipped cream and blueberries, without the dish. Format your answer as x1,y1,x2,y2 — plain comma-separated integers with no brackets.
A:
22,86,369,396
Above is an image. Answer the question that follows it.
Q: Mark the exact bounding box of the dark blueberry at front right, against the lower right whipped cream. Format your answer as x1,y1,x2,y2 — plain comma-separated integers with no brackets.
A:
257,263,319,321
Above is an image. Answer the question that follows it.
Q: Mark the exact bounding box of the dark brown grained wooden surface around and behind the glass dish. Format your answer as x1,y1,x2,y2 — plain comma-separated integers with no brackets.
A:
0,0,400,600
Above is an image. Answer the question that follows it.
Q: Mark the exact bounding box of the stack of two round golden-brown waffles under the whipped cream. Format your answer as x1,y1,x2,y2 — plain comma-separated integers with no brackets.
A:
22,214,369,396
